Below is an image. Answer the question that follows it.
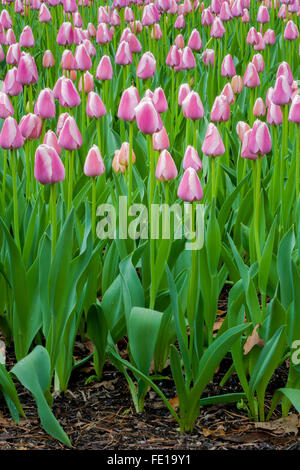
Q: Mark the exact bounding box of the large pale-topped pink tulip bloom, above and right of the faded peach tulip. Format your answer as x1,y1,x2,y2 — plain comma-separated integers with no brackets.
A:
135,98,163,134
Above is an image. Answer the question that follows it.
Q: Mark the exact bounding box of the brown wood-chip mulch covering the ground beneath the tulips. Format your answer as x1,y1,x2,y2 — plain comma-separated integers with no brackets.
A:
0,284,300,451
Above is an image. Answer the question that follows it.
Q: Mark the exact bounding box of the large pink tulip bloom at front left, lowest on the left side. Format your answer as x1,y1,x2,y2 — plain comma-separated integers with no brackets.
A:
34,144,65,185
